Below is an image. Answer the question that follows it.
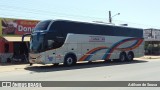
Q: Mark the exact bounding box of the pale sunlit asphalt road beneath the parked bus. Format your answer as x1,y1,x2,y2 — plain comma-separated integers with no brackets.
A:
0,59,160,90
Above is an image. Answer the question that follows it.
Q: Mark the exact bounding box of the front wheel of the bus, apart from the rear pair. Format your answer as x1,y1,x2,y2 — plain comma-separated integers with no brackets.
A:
64,54,77,66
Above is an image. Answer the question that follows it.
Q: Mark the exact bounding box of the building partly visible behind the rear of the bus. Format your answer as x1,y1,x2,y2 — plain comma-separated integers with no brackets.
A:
144,28,160,55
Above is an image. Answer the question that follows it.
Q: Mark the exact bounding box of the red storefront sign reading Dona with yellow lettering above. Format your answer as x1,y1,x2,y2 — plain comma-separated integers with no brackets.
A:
2,18,39,35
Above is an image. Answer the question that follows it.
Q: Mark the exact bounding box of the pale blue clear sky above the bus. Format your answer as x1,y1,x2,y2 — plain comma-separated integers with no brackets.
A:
0,0,160,29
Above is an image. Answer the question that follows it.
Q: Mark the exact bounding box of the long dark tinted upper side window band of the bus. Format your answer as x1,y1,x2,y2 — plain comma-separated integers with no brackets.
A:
49,20,143,38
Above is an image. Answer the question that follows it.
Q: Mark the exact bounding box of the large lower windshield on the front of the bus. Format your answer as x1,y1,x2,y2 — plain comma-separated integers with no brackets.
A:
30,34,44,53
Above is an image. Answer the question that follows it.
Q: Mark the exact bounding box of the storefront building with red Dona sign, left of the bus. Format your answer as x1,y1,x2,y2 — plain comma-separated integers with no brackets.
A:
0,18,39,63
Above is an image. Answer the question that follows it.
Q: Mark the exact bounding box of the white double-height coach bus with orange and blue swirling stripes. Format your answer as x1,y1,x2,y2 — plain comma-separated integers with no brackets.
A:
23,20,144,66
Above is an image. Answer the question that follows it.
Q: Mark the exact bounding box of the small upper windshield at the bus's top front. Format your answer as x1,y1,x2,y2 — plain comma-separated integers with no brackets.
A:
34,20,51,31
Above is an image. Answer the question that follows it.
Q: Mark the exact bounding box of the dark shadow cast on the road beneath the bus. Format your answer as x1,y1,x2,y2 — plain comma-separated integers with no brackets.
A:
25,60,148,72
